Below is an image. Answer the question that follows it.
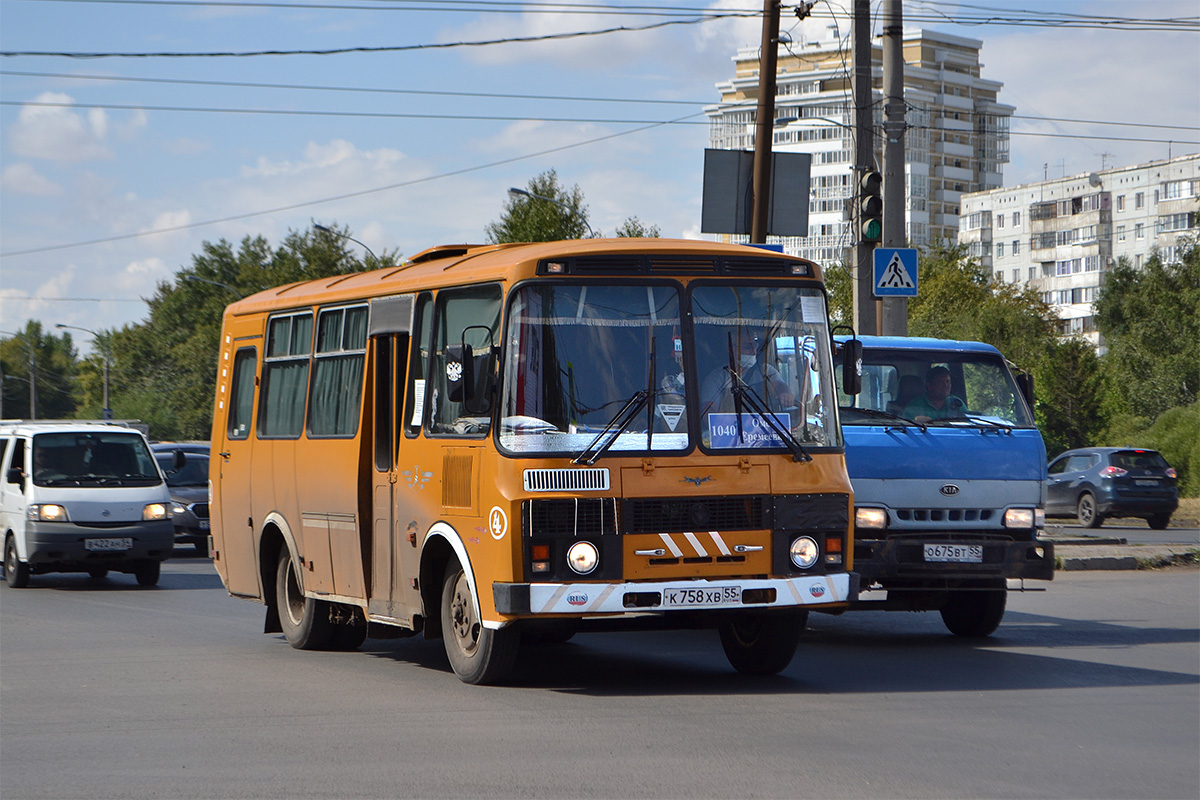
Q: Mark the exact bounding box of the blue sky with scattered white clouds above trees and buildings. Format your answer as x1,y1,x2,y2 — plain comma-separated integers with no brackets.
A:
0,0,1200,353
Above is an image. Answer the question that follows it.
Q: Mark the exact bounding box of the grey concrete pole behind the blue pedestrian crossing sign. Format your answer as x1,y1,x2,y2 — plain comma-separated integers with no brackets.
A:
881,0,908,336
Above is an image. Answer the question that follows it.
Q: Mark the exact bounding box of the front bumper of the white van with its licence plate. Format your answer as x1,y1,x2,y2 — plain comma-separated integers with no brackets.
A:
24,519,175,570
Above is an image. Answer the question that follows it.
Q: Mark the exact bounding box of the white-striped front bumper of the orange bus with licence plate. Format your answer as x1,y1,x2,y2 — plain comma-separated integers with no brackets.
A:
492,572,858,616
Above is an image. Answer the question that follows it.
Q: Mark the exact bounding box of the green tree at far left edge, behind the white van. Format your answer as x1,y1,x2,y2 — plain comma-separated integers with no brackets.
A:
0,320,77,420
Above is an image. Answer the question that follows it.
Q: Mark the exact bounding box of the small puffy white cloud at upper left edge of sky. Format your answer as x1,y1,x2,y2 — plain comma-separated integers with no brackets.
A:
8,91,113,162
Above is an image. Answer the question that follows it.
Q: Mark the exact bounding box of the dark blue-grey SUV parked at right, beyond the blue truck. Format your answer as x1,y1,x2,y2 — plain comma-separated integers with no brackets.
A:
1046,447,1180,529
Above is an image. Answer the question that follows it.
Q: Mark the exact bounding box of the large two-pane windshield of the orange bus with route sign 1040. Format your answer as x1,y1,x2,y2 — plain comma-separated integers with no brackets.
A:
499,282,840,457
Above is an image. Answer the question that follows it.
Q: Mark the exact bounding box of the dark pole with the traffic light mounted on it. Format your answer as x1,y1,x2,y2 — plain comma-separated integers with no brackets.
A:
851,0,880,335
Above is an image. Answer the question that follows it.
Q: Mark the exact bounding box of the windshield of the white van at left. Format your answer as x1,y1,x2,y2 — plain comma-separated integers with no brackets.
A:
32,431,162,486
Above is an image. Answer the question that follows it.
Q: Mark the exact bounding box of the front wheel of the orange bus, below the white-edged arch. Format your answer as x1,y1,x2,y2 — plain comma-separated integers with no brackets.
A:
440,561,521,685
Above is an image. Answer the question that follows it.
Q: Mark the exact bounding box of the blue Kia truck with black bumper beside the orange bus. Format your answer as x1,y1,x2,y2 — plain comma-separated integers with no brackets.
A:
835,336,1055,637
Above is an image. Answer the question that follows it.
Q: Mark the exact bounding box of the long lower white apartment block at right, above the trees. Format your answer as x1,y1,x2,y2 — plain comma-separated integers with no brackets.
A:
959,154,1200,348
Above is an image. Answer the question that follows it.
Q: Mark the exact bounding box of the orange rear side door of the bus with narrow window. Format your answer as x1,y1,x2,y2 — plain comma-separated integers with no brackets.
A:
209,323,263,597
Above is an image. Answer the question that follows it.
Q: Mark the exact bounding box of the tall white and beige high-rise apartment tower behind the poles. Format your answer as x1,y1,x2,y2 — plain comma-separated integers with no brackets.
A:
704,31,1014,264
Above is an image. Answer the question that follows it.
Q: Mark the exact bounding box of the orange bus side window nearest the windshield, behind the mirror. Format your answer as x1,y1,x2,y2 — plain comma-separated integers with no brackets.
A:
426,285,500,437
